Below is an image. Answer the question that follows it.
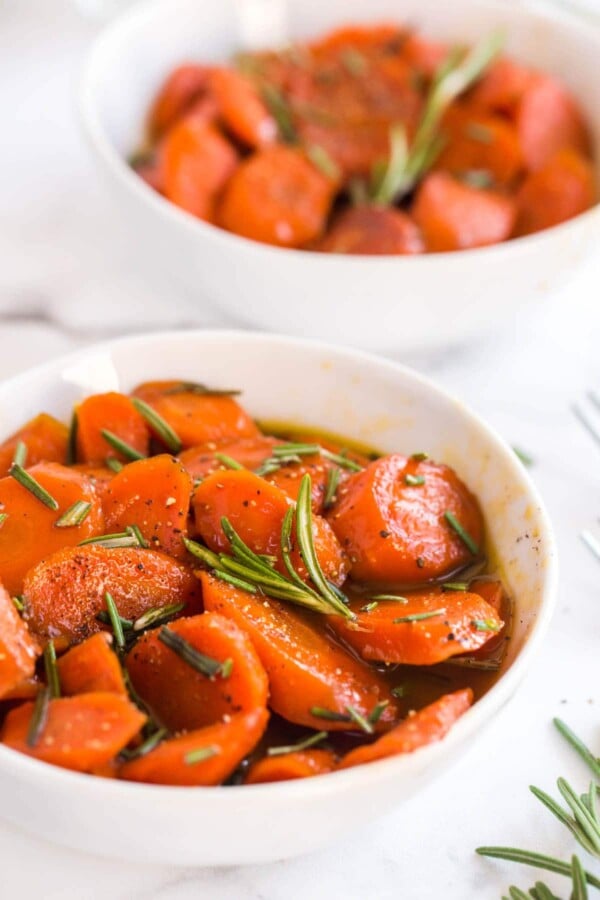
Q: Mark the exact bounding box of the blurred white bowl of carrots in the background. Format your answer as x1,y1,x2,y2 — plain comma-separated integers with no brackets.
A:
80,0,600,351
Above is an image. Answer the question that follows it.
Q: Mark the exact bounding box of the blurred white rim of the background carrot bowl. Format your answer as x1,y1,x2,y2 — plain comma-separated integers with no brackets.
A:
78,0,600,269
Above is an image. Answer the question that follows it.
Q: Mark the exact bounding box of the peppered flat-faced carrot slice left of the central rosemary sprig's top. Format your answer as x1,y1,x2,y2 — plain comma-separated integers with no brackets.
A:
104,454,192,557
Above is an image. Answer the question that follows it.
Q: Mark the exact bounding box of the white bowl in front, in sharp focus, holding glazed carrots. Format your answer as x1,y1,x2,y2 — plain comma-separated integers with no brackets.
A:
0,331,557,865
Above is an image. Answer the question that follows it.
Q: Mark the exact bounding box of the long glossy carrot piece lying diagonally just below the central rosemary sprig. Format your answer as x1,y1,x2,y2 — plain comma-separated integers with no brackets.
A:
200,572,396,731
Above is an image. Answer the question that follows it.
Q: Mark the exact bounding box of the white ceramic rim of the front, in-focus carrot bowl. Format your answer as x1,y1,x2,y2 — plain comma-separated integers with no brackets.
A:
0,330,558,803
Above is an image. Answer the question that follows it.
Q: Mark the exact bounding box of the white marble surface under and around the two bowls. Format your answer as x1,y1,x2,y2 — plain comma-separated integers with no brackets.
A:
0,0,600,900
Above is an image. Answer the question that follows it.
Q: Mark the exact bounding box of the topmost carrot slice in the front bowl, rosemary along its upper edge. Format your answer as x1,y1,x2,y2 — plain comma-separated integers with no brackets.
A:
133,382,260,447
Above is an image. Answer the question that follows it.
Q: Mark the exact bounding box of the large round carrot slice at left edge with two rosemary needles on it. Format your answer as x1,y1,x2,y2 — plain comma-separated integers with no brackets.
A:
0,463,104,594
